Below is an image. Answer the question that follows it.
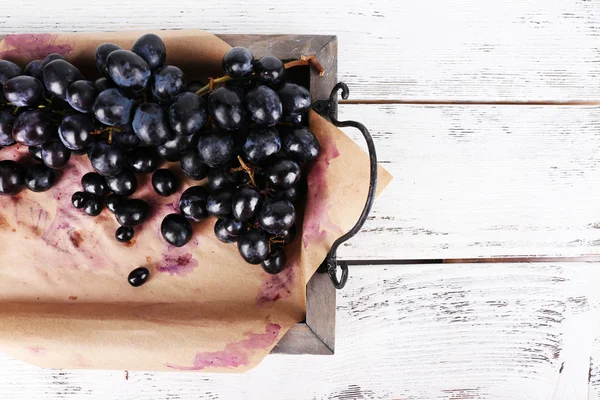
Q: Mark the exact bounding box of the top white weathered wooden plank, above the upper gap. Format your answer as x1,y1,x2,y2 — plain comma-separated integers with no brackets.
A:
0,0,600,101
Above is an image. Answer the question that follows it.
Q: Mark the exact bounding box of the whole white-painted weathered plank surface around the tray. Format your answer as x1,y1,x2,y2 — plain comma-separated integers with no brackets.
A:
0,0,600,400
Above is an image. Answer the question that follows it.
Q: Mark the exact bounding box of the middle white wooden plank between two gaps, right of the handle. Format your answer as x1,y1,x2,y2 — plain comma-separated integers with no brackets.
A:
340,105,600,259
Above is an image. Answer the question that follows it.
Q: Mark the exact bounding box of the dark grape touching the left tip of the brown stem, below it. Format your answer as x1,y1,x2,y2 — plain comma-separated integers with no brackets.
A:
169,93,207,136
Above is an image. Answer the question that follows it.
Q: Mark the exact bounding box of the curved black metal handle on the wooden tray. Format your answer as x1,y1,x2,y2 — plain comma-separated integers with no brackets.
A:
315,82,377,289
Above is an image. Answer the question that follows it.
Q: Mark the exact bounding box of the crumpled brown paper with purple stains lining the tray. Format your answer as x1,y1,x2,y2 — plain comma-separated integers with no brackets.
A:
0,30,391,372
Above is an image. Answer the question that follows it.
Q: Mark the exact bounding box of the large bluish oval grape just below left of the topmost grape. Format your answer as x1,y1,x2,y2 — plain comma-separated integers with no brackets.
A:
106,50,151,91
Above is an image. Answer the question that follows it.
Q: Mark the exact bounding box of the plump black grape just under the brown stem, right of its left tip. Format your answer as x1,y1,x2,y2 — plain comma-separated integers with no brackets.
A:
208,87,244,131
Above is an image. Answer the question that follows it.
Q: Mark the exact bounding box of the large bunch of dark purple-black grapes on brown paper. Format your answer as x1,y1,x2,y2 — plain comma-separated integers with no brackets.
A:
0,34,320,280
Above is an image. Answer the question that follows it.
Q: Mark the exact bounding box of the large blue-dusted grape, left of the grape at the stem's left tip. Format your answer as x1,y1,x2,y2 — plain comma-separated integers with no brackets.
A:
132,103,174,146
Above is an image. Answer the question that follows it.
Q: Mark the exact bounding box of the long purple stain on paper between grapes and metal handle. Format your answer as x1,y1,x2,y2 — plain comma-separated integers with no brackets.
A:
302,136,340,248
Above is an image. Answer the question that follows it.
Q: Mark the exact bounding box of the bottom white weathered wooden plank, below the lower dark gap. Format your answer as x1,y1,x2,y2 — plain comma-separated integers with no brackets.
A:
0,263,600,400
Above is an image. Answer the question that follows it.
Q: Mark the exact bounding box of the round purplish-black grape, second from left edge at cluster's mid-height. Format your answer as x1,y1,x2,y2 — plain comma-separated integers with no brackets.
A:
12,110,56,146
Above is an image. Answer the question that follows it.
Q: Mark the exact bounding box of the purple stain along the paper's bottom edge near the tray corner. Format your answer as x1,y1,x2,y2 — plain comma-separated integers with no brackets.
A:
165,323,281,371
